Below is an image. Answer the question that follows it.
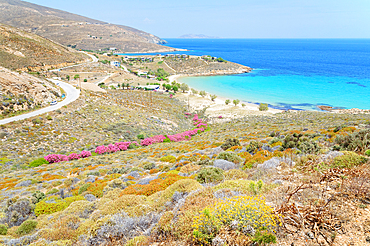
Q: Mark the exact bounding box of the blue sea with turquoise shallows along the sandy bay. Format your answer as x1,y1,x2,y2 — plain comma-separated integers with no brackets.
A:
123,39,370,110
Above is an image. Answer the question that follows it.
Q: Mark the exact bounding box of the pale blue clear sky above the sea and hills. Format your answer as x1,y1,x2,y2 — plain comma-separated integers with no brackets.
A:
27,0,370,38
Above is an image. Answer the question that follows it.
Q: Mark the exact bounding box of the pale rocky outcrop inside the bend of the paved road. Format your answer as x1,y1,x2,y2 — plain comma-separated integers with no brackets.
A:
0,67,61,116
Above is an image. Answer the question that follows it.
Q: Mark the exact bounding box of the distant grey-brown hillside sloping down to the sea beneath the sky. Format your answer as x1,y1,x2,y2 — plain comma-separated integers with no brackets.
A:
0,0,173,52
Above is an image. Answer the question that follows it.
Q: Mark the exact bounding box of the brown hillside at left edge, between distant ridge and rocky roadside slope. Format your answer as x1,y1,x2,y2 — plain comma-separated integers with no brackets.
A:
0,24,89,70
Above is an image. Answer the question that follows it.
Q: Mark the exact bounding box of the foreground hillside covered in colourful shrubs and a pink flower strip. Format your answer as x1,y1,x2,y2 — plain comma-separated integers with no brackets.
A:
0,85,370,246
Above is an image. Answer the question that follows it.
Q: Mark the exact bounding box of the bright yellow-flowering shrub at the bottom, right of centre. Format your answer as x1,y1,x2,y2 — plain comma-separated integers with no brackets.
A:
192,196,279,243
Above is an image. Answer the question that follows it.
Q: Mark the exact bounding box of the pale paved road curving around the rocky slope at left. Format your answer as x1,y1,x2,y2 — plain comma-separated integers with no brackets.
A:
0,79,80,125
